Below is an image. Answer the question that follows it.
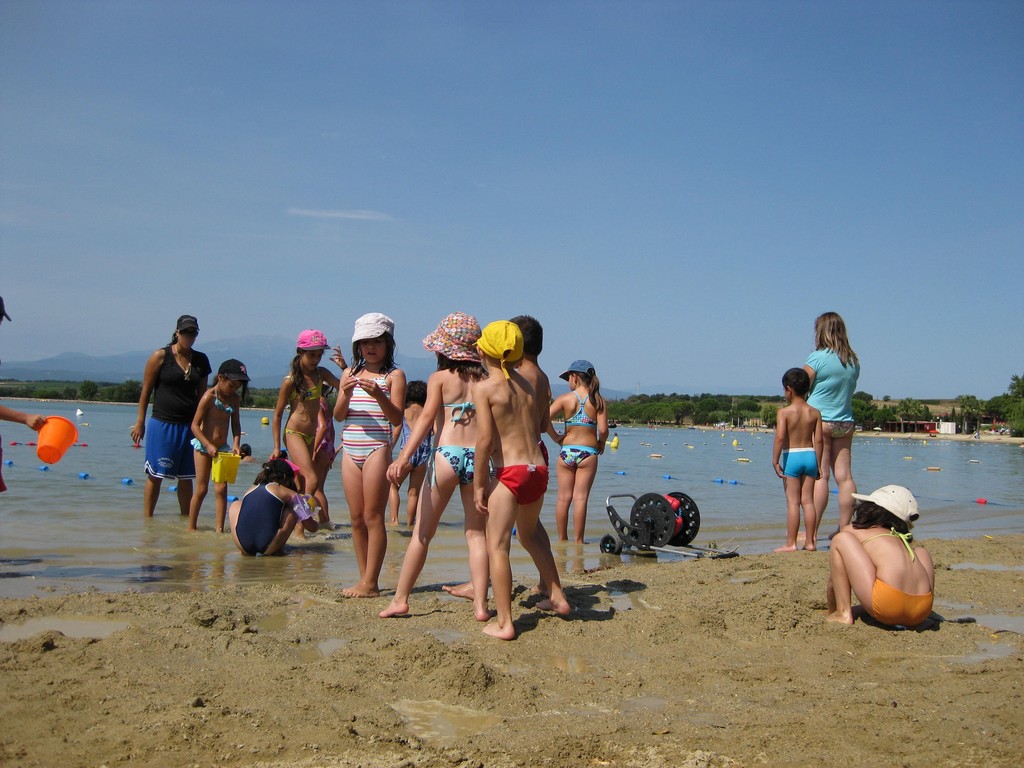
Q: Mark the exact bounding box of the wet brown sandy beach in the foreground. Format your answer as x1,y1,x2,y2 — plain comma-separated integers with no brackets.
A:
0,536,1024,768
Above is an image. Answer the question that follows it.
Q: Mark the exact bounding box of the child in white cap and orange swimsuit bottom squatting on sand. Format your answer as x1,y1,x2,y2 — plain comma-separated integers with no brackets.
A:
826,485,935,627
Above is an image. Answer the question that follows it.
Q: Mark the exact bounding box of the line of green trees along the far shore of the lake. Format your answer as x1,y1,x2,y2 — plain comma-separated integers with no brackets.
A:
0,374,1024,437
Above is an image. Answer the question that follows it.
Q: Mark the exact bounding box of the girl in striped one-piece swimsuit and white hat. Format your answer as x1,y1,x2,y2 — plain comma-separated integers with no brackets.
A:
334,312,406,597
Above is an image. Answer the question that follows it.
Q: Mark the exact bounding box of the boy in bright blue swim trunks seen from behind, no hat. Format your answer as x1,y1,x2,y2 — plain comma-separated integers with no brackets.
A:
772,368,822,552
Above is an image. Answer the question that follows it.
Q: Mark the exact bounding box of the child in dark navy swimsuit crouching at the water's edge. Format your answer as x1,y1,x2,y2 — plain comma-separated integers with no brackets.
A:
228,459,319,555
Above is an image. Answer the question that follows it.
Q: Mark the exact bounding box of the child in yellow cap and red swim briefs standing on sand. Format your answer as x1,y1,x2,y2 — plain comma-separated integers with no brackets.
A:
473,321,571,640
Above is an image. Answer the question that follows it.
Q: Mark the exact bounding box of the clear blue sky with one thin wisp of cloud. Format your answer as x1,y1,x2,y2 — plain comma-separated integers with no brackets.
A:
0,0,1024,399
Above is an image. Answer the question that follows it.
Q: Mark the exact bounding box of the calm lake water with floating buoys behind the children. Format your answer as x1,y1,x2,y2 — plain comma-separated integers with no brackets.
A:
0,400,1024,597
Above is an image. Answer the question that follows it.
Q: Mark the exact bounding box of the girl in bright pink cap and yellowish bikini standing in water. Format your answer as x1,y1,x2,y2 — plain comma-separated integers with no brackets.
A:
270,329,345,509
